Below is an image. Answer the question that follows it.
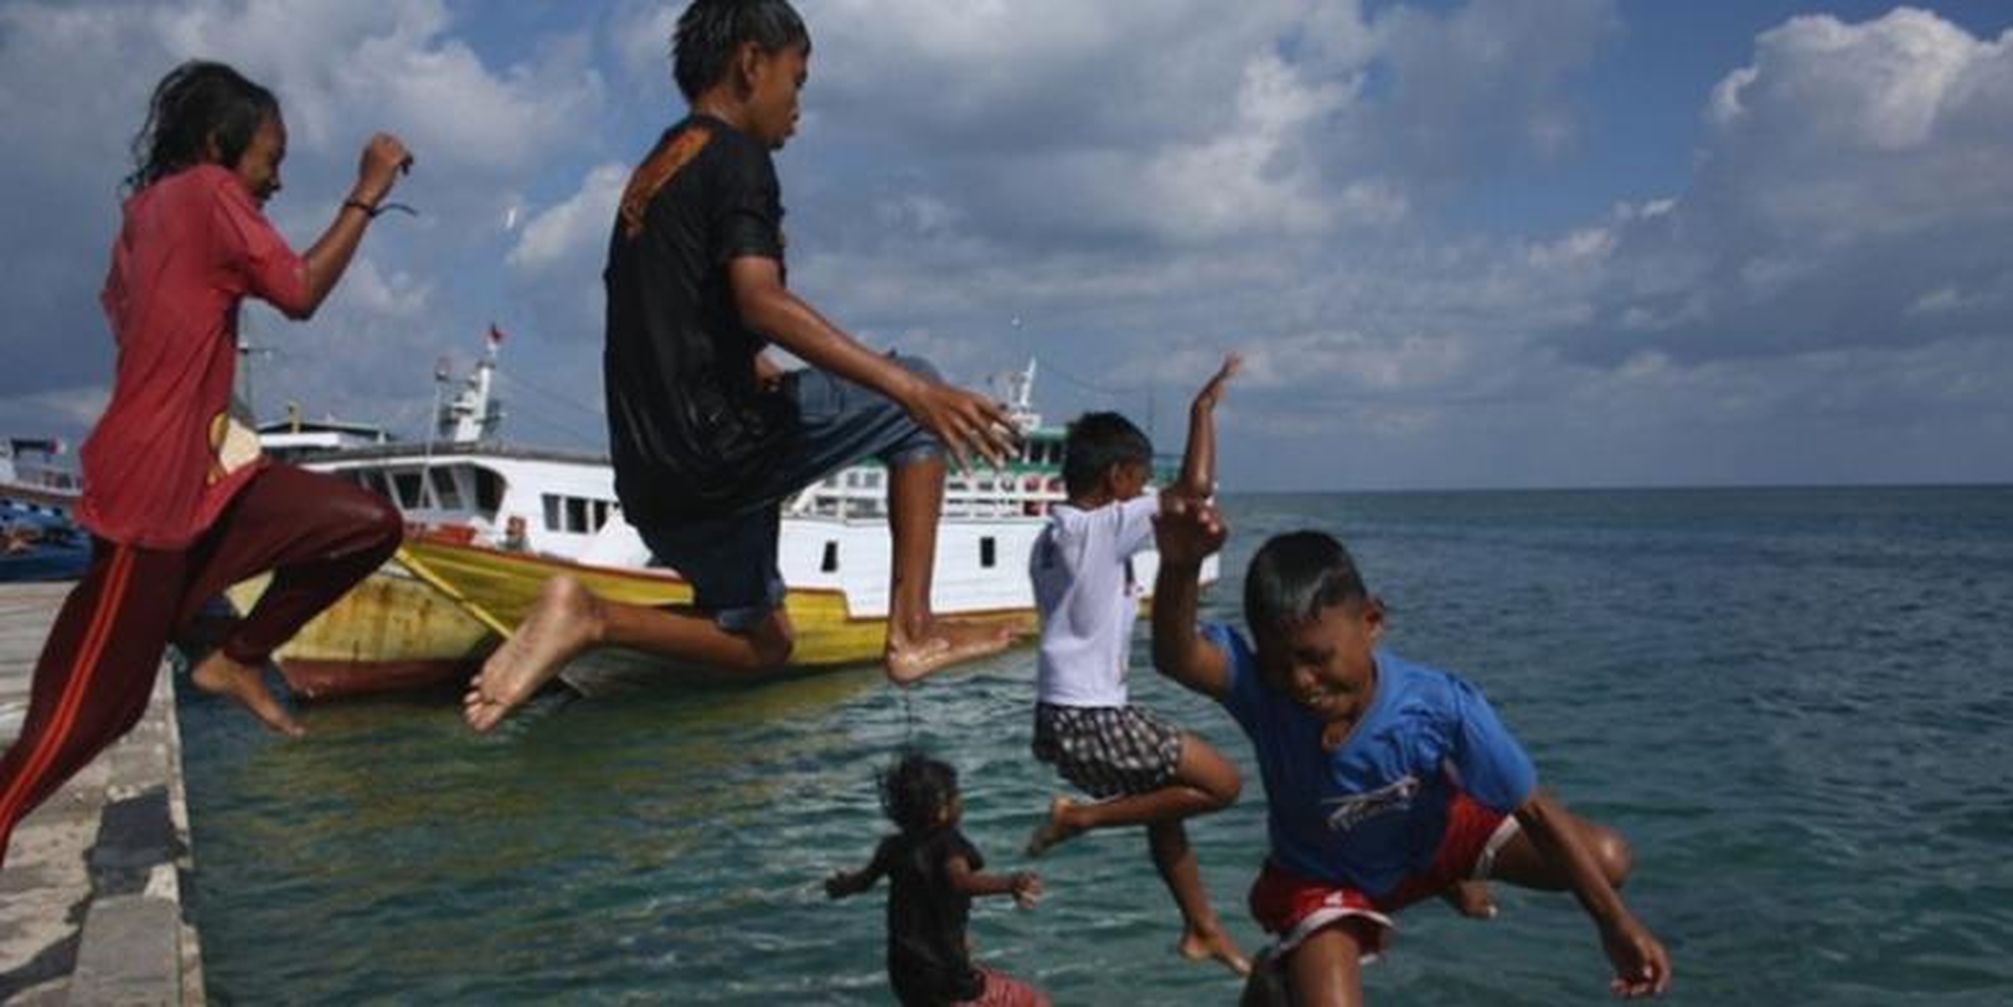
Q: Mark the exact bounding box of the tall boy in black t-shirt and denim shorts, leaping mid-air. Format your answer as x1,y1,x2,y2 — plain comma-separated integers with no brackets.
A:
463,0,1017,731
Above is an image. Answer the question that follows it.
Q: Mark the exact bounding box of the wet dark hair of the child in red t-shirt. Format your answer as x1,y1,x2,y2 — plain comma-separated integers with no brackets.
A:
125,60,280,191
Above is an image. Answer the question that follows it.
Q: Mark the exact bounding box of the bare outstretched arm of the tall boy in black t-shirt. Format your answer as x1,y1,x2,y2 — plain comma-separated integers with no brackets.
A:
727,256,1019,467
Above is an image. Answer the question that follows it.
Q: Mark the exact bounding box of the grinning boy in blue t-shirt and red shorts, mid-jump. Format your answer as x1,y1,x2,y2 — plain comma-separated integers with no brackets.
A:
1153,507,1671,1005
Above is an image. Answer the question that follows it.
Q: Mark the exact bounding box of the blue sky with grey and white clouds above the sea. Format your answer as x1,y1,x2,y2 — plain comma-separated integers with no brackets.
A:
0,0,2013,491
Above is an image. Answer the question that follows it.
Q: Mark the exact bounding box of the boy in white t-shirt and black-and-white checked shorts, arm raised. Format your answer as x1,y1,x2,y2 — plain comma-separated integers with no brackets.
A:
1027,354,1250,975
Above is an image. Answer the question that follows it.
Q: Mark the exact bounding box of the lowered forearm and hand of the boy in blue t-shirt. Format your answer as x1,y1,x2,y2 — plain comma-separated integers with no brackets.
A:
1516,789,1671,997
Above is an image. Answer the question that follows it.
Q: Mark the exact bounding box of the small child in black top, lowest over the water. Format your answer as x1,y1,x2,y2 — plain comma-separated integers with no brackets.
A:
825,753,1049,1007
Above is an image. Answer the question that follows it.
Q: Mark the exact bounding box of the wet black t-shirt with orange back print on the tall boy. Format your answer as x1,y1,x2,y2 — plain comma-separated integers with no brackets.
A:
602,115,795,526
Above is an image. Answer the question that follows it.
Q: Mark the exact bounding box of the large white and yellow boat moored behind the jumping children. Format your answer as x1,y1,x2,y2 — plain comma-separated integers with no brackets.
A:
234,340,1216,697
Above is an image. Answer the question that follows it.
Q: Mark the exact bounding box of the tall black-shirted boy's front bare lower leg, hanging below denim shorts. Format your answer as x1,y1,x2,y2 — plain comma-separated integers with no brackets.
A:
886,457,1013,685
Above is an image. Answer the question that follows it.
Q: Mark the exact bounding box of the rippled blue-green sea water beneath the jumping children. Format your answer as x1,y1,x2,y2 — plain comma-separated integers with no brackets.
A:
181,487,2013,1005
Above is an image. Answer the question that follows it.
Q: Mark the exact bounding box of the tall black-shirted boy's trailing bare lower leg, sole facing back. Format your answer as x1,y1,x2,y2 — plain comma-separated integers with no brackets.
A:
461,576,793,731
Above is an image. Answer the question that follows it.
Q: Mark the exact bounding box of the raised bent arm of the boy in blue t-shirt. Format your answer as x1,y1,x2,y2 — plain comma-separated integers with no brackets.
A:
1153,493,1230,699
